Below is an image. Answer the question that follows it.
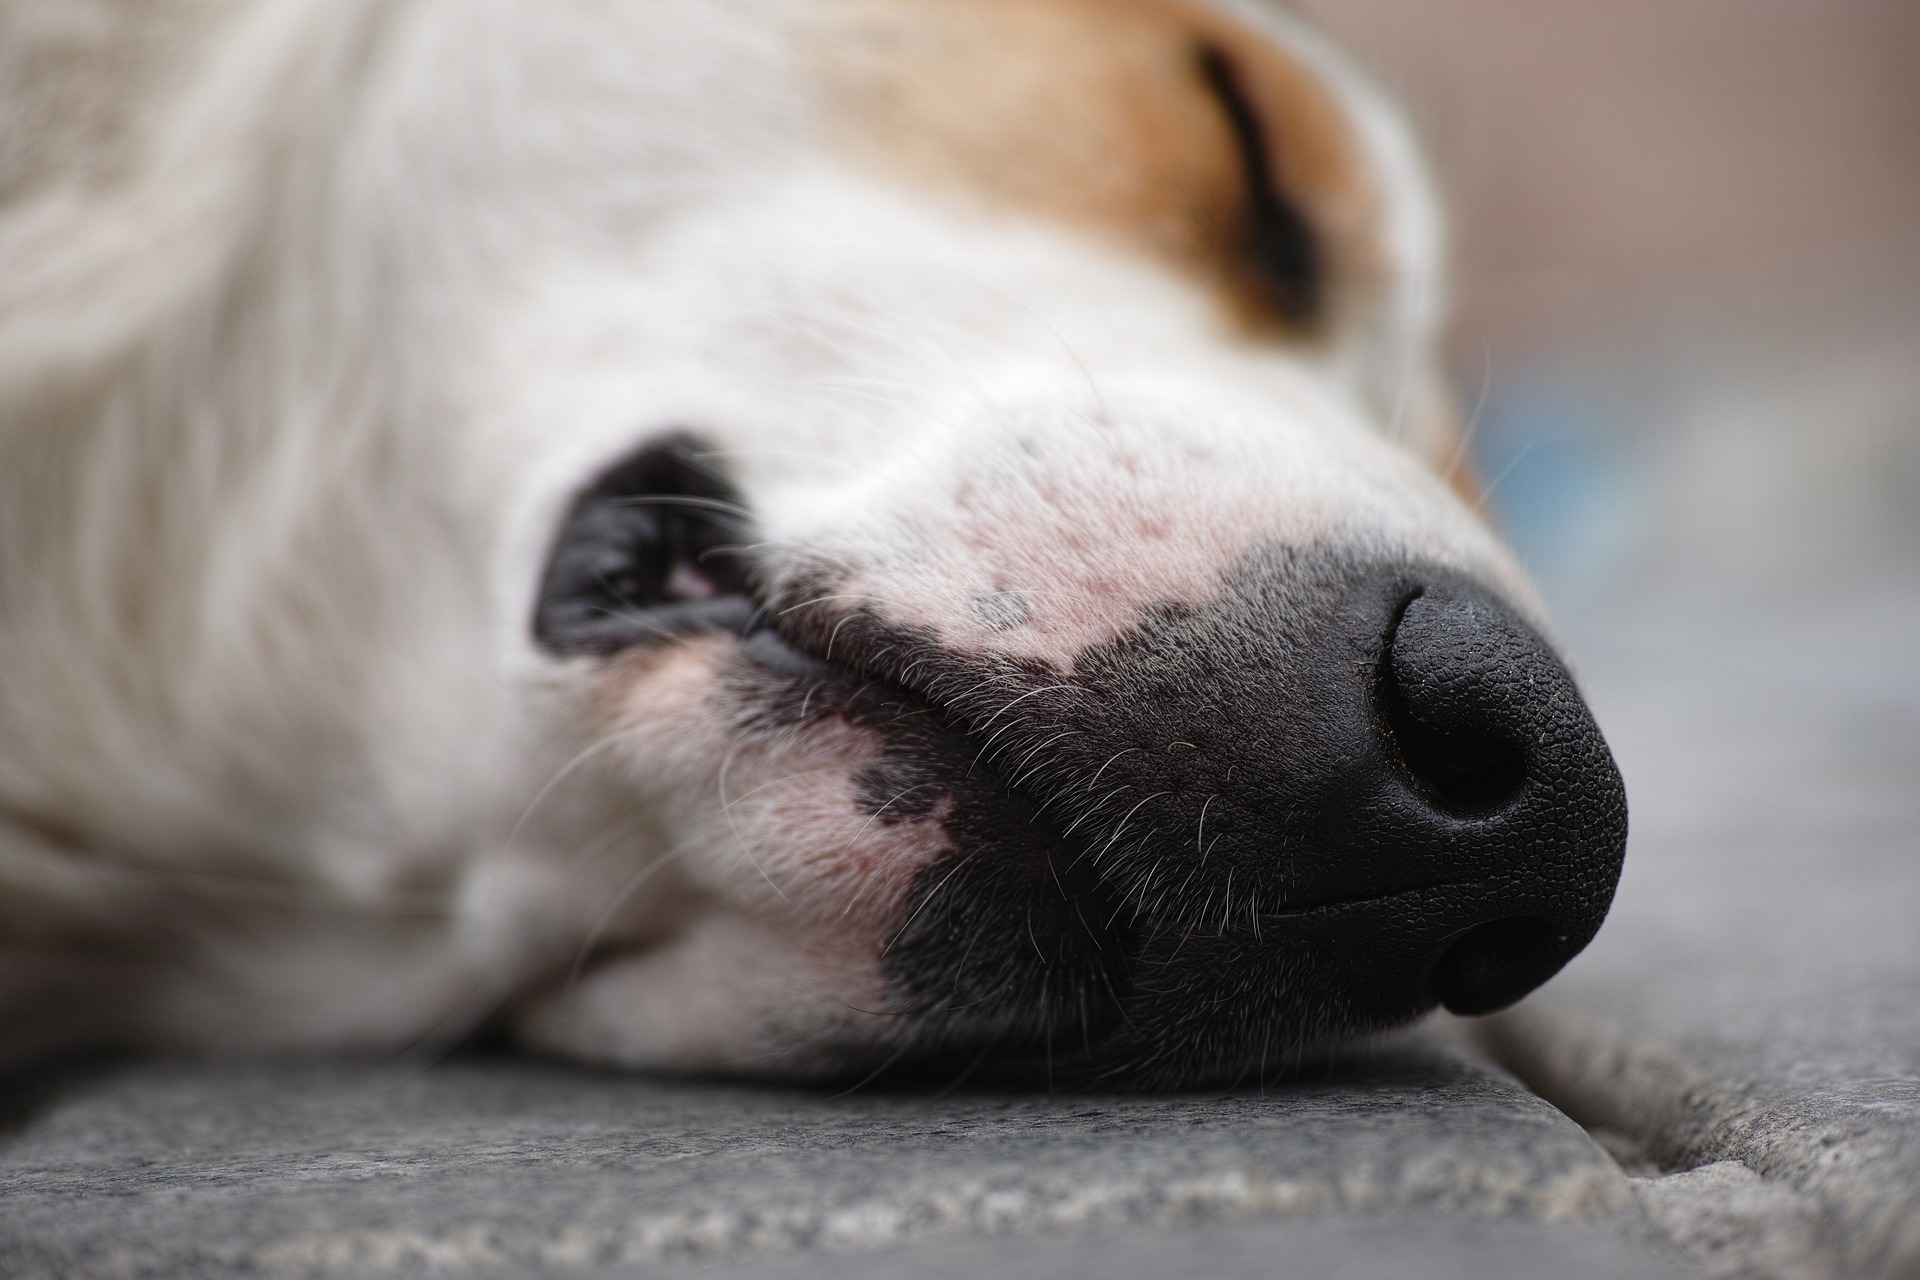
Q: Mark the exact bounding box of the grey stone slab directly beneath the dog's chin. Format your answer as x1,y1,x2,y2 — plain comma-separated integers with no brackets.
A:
0,1038,1681,1276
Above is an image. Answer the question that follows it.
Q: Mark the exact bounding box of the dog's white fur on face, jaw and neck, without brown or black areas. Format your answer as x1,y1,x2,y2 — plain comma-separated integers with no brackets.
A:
0,0,1526,1071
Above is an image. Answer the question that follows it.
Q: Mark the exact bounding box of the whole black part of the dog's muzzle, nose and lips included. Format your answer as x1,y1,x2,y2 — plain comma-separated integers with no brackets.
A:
745,551,1626,1084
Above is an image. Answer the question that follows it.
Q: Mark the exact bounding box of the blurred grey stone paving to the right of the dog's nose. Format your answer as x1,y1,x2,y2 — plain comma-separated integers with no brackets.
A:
1482,566,1920,1276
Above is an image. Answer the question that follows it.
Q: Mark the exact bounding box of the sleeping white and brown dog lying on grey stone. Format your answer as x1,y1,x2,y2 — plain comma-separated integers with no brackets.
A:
0,0,1626,1086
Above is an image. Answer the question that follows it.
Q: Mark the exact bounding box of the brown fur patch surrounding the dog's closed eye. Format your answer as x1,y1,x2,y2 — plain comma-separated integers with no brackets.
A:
814,0,1379,330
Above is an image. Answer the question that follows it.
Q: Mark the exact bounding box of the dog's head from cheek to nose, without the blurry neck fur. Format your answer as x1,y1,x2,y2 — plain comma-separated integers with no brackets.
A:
412,0,1626,1084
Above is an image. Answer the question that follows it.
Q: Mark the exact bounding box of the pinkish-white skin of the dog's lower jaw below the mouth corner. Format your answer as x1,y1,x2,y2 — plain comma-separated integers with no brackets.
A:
522,635,983,1077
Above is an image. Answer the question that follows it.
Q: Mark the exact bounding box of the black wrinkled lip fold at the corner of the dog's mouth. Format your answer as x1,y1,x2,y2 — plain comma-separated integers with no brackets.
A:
534,436,753,654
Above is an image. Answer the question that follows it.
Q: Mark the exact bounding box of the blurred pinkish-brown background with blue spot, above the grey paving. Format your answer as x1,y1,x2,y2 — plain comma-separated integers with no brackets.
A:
1294,0,1920,614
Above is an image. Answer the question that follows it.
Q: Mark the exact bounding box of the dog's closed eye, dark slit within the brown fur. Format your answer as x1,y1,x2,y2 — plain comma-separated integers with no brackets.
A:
1198,44,1327,324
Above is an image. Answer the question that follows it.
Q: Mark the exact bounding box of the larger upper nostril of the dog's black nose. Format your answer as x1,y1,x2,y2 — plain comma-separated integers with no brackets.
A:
1379,597,1526,816
